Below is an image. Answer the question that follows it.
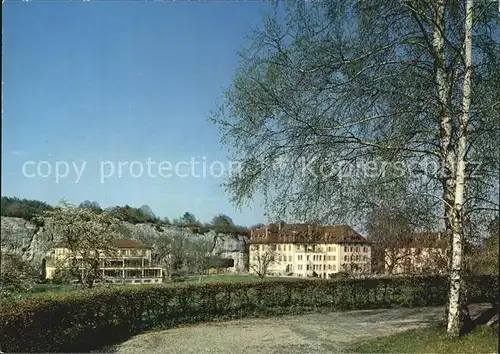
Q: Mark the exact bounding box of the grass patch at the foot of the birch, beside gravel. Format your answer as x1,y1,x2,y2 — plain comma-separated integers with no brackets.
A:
352,326,498,353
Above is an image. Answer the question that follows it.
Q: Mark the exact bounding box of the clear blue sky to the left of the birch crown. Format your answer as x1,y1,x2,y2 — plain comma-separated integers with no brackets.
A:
2,0,269,225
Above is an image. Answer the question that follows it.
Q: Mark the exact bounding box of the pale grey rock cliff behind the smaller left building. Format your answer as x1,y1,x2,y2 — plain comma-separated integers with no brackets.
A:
1,216,248,273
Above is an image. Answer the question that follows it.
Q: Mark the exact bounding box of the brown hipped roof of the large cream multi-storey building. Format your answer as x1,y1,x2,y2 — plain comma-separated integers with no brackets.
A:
250,223,370,244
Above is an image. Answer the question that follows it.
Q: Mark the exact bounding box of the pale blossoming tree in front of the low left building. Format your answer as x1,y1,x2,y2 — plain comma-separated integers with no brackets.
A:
44,202,119,288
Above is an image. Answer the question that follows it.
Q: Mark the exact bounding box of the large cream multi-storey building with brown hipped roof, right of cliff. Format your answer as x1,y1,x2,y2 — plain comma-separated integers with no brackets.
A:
249,223,371,278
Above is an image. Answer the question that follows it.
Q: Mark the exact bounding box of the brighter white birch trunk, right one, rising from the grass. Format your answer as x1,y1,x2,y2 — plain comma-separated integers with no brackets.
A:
448,0,473,336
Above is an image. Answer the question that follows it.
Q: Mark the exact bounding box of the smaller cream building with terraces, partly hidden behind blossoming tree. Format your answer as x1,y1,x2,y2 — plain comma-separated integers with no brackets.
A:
45,239,163,284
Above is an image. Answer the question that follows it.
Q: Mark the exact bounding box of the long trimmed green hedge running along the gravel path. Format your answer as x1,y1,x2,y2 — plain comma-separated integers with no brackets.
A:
0,276,498,352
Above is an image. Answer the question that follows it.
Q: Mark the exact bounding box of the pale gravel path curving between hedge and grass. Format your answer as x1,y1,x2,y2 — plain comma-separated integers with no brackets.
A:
101,307,444,354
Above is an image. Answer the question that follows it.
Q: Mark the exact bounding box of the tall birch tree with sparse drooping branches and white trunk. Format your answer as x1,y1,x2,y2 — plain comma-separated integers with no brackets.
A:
211,0,500,335
